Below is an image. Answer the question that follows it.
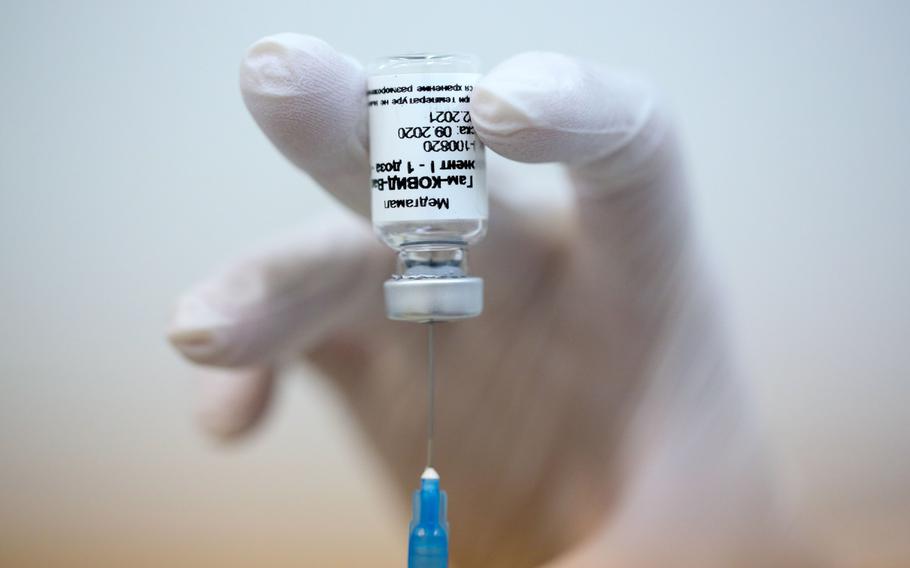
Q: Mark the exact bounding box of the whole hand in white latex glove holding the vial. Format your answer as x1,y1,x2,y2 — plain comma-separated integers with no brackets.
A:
169,34,805,568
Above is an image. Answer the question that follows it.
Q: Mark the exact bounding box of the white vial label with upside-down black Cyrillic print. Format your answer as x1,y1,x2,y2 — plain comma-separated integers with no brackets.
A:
367,73,488,225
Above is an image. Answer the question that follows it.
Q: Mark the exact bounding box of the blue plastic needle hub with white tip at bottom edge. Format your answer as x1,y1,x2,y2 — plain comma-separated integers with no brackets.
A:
408,467,449,568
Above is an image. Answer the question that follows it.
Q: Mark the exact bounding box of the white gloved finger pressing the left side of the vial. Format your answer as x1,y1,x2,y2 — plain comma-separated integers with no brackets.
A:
240,33,370,216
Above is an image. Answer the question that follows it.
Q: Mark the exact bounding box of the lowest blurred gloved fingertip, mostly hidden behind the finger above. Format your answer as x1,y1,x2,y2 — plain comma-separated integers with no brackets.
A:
196,366,275,440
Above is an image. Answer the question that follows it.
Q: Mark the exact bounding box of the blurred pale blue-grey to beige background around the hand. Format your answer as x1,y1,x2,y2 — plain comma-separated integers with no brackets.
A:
0,0,910,568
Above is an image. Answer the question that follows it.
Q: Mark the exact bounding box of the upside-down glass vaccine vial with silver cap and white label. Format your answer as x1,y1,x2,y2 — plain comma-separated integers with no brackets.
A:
367,53,489,322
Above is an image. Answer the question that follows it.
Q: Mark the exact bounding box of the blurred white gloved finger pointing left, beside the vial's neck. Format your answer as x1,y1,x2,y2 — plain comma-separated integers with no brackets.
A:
168,216,391,367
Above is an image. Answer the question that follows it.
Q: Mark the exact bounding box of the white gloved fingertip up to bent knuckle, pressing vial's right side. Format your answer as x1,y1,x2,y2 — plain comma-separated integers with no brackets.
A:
471,52,671,189
